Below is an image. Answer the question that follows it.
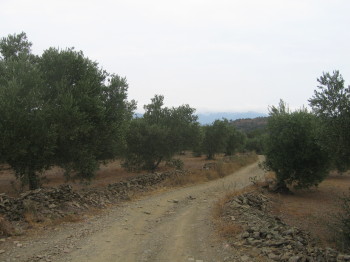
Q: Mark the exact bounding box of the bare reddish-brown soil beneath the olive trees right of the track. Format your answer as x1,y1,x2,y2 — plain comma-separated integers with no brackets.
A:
269,172,350,248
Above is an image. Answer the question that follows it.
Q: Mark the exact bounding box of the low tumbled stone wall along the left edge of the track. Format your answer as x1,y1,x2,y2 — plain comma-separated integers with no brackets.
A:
0,170,186,225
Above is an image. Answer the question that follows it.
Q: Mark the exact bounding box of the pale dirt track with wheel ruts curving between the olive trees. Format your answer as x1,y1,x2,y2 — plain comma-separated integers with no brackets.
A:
0,157,263,262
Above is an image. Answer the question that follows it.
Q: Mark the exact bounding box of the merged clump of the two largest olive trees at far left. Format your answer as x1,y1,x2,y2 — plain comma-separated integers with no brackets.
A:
0,33,135,189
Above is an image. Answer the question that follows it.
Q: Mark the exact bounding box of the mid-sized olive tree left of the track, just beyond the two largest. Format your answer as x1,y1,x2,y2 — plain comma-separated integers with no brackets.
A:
124,95,199,171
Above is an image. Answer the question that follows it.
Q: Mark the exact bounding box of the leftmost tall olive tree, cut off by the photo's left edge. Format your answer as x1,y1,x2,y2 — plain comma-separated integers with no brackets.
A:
0,34,56,189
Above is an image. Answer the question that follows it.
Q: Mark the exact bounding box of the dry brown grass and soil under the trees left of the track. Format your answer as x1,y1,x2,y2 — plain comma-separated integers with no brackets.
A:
0,152,257,196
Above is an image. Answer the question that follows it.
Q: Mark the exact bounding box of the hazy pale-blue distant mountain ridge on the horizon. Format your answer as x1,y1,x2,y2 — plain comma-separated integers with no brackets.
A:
198,112,267,125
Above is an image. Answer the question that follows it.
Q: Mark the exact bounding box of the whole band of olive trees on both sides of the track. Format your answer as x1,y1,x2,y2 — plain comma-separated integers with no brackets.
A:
0,33,350,190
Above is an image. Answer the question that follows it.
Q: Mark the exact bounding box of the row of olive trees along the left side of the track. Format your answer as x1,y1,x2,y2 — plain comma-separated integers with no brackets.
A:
0,32,250,189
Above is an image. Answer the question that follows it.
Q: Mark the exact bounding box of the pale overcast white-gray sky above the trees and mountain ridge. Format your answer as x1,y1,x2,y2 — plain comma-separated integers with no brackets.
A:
0,0,350,112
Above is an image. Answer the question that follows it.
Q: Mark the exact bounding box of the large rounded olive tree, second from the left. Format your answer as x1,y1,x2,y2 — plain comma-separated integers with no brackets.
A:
39,48,134,179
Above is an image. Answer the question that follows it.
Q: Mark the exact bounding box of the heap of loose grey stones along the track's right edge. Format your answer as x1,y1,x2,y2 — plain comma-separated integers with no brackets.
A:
225,192,350,262
